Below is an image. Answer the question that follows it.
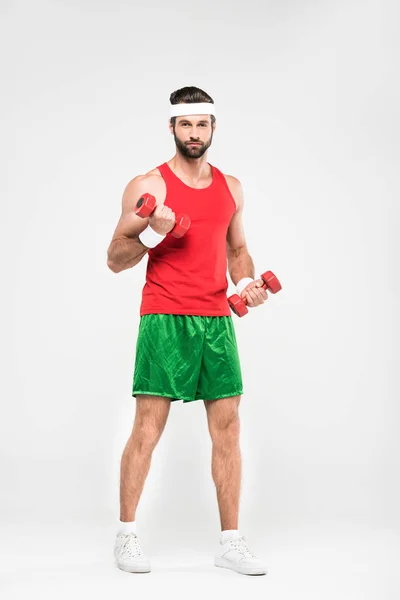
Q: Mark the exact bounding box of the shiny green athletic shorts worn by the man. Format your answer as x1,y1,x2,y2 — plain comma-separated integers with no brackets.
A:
132,314,243,402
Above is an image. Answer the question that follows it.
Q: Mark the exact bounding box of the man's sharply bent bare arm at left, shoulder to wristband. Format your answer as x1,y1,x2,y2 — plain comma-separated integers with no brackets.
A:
107,175,149,273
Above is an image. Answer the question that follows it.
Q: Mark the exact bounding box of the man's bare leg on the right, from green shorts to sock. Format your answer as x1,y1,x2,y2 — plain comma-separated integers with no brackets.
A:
204,396,242,531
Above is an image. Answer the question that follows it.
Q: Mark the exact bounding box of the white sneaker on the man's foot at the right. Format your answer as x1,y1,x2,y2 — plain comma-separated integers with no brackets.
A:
214,535,267,575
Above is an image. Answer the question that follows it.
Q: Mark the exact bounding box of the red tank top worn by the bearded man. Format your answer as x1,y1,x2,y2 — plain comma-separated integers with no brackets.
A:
140,163,236,316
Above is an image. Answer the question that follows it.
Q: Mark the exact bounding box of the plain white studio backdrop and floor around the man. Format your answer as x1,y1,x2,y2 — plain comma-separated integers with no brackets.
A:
0,0,400,600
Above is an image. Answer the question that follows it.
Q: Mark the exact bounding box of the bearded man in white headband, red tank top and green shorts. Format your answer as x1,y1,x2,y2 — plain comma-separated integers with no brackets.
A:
107,87,267,575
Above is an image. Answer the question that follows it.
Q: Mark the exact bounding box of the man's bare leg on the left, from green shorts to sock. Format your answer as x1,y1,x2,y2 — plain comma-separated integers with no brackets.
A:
120,395,171,522
